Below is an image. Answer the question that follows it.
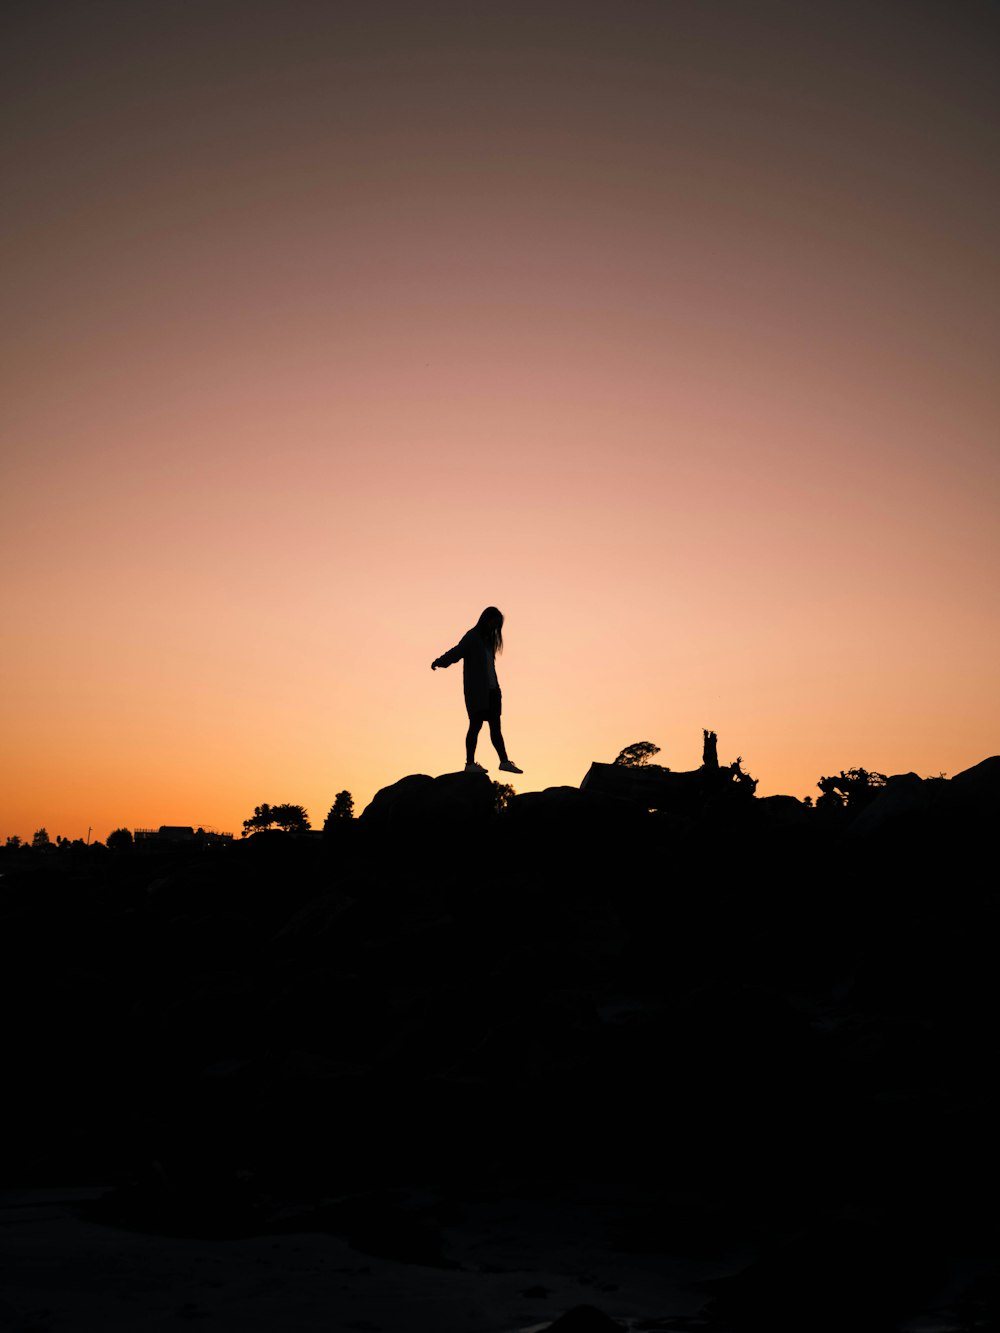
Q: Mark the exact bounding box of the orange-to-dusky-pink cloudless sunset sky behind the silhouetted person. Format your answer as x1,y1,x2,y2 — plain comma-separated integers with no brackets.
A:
0,0,1000,838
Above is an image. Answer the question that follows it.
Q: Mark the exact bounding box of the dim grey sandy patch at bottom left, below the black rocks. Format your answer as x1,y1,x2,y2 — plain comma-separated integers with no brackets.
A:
0,1184,745,1333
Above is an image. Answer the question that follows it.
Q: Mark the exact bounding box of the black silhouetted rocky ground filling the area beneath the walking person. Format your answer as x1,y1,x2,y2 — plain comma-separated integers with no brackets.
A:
0,761,1000,1333
